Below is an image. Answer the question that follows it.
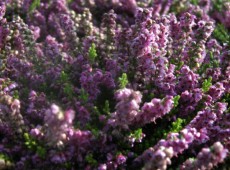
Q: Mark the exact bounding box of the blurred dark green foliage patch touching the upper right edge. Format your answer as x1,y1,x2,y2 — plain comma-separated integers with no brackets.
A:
213,24,230,45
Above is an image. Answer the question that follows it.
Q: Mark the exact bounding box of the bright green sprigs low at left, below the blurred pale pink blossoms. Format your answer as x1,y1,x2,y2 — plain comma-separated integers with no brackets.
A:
24,133,46,158
